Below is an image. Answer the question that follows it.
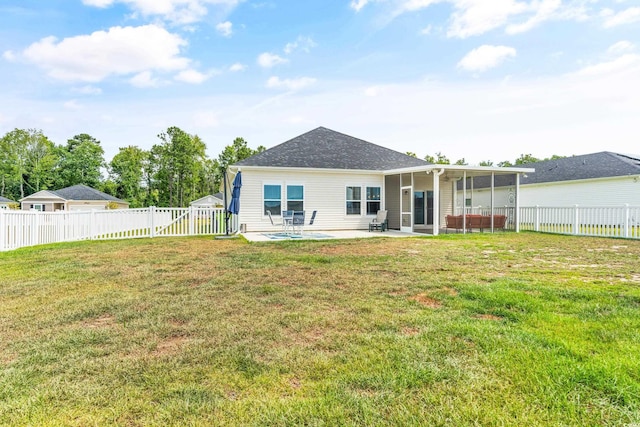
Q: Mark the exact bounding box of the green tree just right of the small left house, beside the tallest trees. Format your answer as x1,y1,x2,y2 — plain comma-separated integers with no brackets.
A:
109,145,149,208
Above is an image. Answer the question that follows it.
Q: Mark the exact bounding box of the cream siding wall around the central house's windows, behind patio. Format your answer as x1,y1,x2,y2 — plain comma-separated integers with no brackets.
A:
239,168,384,232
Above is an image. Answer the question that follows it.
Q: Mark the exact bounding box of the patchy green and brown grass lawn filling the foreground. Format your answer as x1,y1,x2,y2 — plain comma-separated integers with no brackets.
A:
0,233,640,426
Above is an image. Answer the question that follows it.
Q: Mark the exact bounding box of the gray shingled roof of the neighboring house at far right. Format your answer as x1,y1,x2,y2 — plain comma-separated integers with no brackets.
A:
459,151,640,188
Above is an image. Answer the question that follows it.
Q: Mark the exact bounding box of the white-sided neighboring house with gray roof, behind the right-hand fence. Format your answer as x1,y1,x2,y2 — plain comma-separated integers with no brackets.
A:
457,151,640,207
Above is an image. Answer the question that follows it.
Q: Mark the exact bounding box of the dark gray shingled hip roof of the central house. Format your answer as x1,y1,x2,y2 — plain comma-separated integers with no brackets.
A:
234,127,429,171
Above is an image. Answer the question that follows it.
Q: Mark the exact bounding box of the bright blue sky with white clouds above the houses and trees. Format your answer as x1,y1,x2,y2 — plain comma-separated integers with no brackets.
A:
0,0,640,164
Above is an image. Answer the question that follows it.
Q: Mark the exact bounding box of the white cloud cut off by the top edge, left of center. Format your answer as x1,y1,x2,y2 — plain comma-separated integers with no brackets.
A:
82,0,240,24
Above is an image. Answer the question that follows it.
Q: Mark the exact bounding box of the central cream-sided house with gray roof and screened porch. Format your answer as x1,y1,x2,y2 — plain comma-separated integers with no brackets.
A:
229,127,534,234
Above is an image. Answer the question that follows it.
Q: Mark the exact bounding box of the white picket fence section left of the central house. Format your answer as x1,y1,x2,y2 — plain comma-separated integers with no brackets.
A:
0,206,238,251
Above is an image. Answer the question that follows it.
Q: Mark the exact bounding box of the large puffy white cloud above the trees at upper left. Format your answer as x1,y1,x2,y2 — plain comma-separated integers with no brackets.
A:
22,25,190,82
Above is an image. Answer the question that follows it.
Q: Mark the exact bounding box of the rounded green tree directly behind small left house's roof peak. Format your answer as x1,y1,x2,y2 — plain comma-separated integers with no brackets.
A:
56,133,105,188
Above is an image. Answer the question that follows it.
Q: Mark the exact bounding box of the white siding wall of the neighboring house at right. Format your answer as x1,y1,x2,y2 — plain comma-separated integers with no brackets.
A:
458,176,640,207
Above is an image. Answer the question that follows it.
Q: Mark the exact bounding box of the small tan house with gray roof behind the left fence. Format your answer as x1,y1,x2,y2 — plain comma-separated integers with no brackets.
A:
20,185,129,212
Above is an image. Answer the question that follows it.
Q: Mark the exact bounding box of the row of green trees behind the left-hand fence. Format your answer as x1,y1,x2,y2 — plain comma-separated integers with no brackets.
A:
0,126,265,208
